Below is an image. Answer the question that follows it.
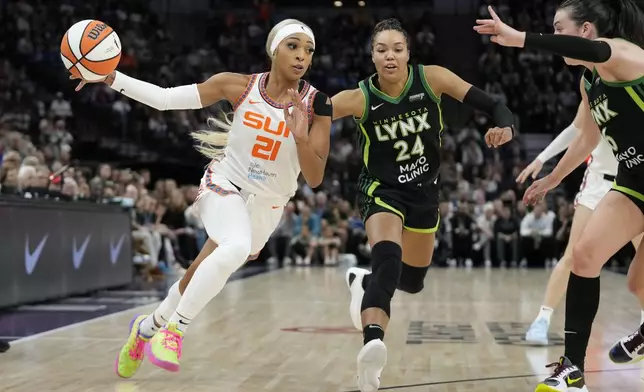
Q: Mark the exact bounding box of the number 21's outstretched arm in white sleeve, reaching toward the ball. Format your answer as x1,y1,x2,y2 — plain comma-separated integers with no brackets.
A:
76,71,250,110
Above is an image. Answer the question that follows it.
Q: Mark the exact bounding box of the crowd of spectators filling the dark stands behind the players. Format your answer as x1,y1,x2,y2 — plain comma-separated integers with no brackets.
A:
0,0,632,277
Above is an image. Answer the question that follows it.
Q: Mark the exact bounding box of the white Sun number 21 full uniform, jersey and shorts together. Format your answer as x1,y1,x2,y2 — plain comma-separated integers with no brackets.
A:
197,73,317,257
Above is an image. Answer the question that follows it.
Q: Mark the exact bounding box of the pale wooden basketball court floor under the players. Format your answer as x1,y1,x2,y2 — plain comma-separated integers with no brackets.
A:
0,268,644,392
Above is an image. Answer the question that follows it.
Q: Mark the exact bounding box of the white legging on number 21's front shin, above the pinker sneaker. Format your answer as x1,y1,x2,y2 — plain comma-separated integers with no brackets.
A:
169,245,250,332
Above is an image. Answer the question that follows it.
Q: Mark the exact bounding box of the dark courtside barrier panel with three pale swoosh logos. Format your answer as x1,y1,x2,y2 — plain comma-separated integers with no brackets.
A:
0,202,132,307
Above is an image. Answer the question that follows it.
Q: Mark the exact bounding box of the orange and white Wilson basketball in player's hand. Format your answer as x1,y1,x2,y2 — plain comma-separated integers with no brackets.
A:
60,19,121,81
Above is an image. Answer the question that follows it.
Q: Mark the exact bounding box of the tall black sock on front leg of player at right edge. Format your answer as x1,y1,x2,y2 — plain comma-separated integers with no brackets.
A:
564,272,600,372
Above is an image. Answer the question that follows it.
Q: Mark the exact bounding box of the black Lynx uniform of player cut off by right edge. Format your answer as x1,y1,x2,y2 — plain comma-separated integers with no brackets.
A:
584,71,644,212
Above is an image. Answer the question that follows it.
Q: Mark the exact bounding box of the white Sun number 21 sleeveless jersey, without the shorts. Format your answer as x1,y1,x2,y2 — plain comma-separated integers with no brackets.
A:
197,73,317,198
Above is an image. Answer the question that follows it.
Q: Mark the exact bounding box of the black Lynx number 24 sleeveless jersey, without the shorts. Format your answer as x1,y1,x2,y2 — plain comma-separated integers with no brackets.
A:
356,65,443,192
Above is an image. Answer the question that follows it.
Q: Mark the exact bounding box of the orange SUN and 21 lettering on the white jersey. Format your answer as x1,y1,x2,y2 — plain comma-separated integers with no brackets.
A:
243,112,290,161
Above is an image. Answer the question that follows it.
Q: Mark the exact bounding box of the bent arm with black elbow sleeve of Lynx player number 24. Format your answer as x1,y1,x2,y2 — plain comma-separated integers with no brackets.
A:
424,65,514,147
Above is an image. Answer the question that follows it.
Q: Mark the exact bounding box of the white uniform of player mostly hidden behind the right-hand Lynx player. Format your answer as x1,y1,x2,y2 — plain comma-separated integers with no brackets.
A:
575,138,617,210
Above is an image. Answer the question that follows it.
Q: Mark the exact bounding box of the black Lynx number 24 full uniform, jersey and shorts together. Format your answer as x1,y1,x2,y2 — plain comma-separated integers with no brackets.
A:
356,65,443,233
